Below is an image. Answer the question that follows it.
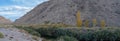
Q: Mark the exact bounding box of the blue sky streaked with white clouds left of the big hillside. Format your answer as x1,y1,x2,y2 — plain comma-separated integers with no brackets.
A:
0,0,48,21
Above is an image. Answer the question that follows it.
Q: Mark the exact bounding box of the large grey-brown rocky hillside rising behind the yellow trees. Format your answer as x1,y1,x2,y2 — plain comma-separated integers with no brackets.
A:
15,0,120,26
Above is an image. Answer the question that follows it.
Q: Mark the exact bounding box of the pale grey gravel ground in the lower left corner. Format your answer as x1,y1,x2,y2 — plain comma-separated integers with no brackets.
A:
0,28,42,41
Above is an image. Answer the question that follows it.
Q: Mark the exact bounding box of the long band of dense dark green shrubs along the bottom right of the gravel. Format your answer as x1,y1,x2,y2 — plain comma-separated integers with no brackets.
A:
14,26,120,41
